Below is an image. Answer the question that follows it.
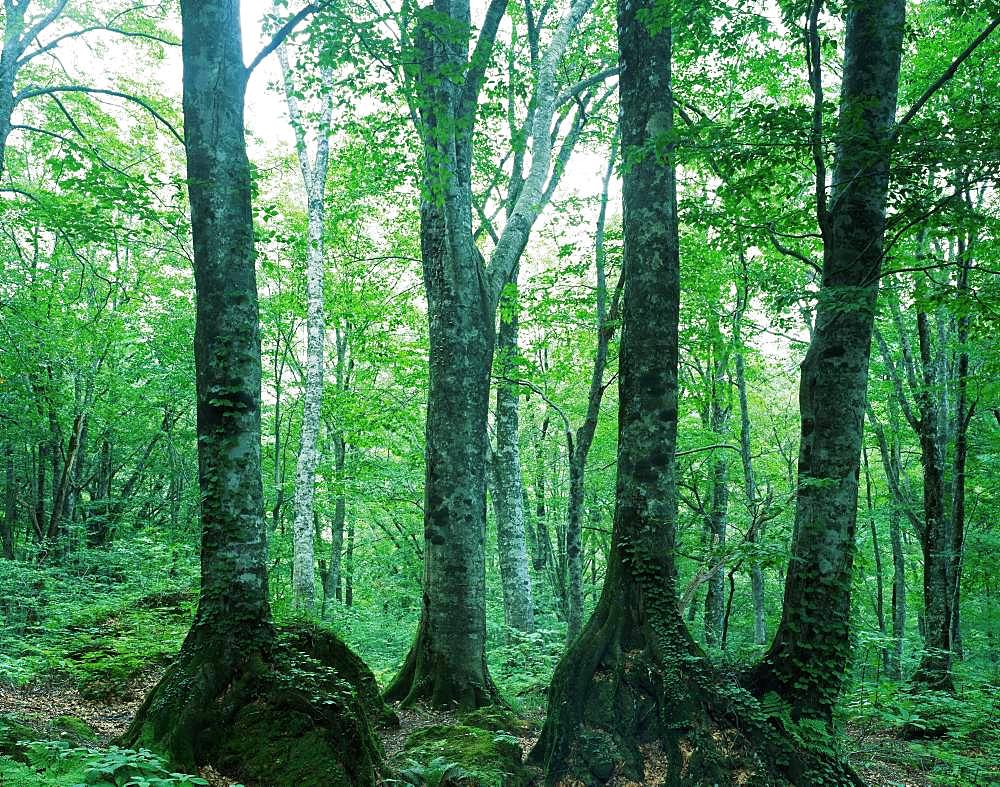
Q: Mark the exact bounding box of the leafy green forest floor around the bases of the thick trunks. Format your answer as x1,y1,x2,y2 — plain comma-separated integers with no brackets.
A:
0,561,1000,787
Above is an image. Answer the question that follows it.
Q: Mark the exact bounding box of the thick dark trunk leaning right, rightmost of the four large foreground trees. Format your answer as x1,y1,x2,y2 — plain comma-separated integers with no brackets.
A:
748,0,905,720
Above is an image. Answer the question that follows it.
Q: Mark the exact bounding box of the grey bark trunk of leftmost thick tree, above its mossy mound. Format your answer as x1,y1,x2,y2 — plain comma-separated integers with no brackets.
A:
181,0,271,647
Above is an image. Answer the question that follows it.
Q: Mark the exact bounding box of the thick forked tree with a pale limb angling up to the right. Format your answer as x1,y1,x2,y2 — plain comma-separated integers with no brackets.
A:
386,0,592,708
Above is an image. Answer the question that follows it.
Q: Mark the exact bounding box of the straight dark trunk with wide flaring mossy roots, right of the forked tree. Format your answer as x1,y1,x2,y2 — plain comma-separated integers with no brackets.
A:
532,10,854,785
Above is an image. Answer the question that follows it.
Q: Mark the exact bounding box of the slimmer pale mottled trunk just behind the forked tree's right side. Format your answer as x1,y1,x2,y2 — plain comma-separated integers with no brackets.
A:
492,284,535,632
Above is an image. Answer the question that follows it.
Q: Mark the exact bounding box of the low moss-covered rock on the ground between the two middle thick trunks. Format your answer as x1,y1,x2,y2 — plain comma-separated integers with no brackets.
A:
397,724,530,787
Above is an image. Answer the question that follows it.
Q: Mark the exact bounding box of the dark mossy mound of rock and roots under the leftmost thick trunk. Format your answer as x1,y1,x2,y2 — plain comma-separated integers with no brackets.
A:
123,628,386,787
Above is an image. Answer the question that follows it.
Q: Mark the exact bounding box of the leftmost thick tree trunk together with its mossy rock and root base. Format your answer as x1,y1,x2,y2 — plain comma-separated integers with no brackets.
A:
117,0,379,785
